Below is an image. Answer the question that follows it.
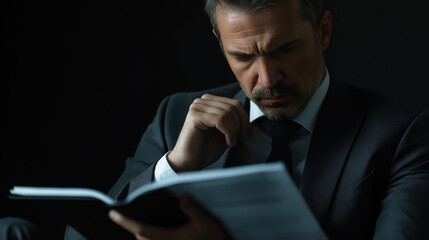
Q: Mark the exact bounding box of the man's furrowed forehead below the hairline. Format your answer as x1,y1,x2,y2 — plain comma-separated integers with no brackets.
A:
216,0,305,49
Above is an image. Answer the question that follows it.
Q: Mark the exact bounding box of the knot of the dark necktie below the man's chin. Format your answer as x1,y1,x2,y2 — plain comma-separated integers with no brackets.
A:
258,117,301,141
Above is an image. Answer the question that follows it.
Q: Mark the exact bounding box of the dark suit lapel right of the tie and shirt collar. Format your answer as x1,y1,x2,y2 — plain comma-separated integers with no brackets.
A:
301,82,364,222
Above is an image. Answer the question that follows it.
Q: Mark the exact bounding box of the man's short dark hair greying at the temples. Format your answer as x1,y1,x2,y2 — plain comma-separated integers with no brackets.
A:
204,0,323,36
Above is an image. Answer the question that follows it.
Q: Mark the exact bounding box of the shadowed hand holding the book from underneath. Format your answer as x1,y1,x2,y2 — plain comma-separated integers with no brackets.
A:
109,196,226,240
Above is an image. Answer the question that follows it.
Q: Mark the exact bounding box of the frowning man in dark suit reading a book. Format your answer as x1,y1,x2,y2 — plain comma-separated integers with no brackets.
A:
63,0,429,239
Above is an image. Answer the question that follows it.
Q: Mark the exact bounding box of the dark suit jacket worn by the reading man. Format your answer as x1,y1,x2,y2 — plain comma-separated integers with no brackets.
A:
65,81,429,239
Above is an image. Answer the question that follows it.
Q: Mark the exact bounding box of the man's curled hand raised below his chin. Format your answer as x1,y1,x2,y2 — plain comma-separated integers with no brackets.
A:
167,94,250,172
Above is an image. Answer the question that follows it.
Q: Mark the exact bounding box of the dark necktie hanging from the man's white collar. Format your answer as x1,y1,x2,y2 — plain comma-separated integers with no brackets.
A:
258,117,301,176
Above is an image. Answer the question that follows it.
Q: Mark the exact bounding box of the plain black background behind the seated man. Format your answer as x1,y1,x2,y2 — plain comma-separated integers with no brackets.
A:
0,0,429,236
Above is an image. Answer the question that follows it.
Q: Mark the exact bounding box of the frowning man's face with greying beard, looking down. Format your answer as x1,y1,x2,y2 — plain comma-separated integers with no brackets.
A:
216,0,331,121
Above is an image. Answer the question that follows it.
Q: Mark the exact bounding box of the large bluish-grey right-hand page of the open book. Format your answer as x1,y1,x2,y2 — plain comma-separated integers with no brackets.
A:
168,163,327,240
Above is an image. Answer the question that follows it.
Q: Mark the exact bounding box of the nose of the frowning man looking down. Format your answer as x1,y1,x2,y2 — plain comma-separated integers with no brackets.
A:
256,56,283,88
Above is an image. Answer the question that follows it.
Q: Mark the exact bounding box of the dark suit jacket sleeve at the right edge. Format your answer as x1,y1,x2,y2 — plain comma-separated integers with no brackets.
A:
374,111,429,239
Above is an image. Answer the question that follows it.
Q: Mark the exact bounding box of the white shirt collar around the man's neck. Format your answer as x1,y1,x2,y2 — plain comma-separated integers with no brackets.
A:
249,70,331,133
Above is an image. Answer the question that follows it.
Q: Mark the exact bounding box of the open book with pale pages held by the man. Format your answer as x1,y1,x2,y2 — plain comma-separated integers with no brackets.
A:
10,163,327,240
